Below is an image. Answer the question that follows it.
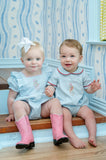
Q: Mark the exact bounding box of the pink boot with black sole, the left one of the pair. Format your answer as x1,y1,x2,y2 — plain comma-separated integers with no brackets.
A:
16,115,35,149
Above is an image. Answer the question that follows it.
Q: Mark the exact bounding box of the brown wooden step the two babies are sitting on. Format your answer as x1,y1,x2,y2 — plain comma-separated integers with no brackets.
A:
0,112,106,133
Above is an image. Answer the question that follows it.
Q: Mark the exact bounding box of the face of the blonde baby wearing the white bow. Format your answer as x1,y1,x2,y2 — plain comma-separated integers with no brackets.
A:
21,47,44,73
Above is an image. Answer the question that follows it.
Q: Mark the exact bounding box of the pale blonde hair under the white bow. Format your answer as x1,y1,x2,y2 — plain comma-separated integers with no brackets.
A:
21,42,44,58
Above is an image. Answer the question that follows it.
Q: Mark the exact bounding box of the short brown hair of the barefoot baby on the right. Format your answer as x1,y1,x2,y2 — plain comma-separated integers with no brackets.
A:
59,39,83,55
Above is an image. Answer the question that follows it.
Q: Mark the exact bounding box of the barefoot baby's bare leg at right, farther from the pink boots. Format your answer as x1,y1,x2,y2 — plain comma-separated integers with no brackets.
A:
77,106,97,147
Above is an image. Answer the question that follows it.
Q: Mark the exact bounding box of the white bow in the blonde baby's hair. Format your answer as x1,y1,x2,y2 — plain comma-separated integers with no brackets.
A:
18,37,36,53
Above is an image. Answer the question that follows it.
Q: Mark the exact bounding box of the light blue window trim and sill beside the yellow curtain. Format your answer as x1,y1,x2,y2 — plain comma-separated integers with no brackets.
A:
86,0,106,45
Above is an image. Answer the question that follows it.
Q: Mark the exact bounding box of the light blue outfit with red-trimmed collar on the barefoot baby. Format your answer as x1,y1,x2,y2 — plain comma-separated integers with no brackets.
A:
48,66,92,115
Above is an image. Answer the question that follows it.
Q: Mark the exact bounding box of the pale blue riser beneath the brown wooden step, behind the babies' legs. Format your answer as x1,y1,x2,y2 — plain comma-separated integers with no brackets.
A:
0,123,106,149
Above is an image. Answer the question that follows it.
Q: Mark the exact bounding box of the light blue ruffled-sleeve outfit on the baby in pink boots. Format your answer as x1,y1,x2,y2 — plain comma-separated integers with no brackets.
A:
8,66,53,119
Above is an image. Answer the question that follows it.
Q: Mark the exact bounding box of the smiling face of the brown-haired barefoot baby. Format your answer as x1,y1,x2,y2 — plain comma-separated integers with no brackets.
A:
60,45,82,73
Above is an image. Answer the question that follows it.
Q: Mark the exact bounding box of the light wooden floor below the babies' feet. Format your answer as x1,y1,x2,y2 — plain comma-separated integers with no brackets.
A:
0,136,106,160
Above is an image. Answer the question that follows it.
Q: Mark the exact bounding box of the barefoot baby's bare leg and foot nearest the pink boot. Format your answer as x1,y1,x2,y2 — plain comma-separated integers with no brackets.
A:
63,108,85,148
